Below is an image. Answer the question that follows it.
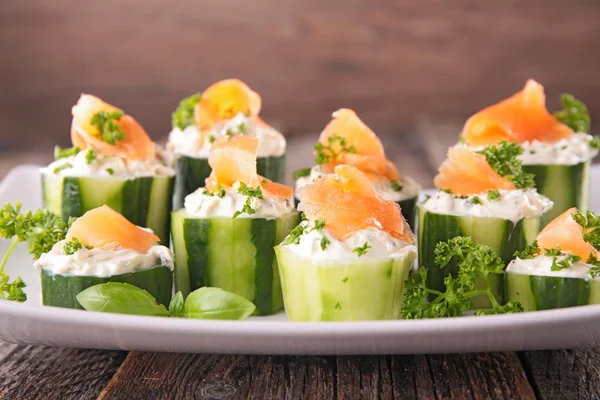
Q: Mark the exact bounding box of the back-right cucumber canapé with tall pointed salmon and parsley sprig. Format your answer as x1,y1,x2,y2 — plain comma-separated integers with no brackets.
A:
461,80,600,221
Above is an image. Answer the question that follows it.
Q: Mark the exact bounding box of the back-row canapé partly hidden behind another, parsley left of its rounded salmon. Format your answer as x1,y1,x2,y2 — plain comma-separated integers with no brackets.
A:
167,79,286,209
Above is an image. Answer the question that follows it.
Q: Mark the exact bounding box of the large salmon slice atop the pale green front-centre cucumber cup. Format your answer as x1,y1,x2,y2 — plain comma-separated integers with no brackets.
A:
298,165,415,243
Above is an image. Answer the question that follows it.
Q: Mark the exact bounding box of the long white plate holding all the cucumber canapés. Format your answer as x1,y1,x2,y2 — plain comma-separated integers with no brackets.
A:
0,166,600,354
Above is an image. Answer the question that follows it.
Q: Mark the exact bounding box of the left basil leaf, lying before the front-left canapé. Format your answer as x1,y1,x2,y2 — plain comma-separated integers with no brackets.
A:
77,282,169,317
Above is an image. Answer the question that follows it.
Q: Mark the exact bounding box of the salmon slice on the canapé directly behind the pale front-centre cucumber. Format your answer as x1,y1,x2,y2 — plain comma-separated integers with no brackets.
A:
319,108,399,180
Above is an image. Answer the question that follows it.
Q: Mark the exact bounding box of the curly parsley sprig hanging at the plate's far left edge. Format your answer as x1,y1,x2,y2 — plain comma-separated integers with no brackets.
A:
0,202,68,301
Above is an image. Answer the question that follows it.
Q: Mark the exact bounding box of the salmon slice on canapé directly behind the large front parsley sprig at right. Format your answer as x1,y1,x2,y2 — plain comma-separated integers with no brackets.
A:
433,147,515,196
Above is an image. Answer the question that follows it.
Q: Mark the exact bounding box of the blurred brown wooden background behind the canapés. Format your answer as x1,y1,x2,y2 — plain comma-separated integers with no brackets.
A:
0,0,600,151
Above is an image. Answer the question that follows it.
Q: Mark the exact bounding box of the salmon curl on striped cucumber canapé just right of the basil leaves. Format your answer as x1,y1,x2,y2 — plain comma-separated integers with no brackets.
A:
206,136,294,199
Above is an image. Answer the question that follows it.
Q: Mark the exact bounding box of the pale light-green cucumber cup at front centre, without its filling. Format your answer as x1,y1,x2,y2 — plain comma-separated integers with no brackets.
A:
275,245,417,321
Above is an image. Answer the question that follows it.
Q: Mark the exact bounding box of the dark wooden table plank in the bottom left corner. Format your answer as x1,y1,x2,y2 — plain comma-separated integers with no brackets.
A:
0,342,126,400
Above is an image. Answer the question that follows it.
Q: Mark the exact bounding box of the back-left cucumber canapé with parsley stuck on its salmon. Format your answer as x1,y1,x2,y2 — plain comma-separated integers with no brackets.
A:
40,94,175,243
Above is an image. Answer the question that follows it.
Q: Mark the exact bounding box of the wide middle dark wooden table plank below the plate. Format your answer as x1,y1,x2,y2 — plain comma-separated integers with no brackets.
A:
100,352,535,400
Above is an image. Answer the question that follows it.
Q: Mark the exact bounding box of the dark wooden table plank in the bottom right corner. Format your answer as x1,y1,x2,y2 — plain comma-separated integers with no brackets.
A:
521,347,600,400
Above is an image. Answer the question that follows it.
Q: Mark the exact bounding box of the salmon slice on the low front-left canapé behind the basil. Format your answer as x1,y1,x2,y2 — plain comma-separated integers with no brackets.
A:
66,206,160,253
